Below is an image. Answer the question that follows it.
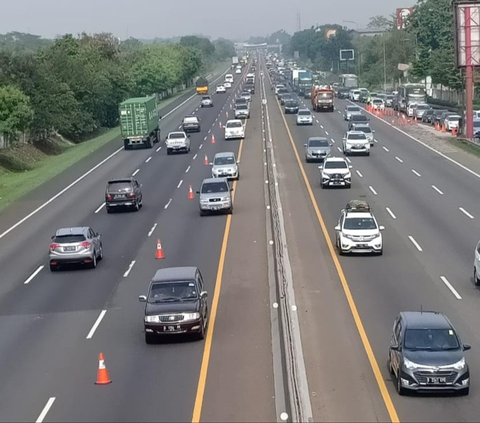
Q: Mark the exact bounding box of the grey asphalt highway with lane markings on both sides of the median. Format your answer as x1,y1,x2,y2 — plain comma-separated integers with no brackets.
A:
0,52,480,422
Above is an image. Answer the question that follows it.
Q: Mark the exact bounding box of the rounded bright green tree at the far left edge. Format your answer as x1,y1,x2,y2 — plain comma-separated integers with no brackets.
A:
0,85,33,140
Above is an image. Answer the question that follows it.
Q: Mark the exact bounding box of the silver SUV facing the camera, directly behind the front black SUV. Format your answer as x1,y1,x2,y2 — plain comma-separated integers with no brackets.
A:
197,178,233,216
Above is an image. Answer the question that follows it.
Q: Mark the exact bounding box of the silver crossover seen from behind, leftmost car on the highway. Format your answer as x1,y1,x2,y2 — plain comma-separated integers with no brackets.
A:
49,227,103,271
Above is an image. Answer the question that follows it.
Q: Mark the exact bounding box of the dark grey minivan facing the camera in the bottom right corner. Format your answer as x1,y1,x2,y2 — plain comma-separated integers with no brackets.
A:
388,311,470,395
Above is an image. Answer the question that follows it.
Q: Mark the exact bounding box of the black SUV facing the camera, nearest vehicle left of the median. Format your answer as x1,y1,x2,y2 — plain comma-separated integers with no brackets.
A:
138,267,208,344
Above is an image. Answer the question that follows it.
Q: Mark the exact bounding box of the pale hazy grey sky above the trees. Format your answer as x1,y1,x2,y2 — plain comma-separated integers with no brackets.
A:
0,0,410,41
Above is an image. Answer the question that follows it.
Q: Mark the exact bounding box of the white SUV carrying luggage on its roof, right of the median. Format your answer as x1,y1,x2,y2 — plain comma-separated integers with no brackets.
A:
335,200,385,255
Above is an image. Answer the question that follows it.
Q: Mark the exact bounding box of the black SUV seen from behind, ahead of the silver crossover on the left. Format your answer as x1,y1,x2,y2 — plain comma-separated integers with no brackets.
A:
105,178,143,213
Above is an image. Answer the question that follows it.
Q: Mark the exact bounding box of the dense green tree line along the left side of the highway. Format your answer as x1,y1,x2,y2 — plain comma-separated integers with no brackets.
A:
0,33,235,141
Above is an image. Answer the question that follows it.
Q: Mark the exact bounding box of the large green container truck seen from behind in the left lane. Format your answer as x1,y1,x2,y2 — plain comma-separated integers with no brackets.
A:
120,96,160,150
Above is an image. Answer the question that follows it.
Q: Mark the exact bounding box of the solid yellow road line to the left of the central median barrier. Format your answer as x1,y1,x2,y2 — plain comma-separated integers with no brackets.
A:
192,121,248,423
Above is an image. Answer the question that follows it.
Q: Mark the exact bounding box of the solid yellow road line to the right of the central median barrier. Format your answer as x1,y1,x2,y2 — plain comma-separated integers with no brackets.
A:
276,100,399,423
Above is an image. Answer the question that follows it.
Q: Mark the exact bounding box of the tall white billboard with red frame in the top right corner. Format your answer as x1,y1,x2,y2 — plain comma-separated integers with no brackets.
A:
454,0,480,68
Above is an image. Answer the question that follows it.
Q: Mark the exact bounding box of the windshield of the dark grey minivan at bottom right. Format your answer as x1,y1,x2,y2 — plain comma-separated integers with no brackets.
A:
405,329,460,351
